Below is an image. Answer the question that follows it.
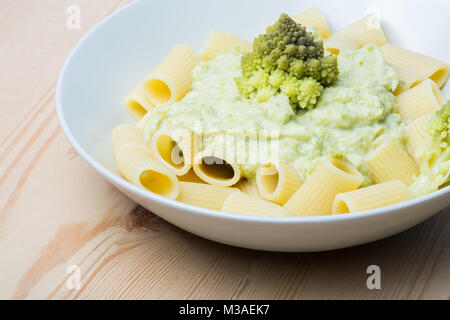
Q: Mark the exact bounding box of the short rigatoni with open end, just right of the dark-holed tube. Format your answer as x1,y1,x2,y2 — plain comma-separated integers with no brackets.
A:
256,163,303,205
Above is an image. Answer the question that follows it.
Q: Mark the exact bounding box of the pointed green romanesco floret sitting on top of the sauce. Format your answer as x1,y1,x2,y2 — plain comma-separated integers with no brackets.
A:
236,14,339,110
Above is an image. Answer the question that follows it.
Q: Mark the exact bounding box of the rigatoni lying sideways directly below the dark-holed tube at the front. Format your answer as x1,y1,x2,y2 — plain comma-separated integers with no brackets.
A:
177,182,237,210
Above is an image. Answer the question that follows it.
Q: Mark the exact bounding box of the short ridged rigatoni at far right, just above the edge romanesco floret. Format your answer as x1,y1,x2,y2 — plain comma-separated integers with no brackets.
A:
396,79,444,121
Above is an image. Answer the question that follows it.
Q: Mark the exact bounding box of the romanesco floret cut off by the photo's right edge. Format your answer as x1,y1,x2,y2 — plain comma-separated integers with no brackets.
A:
411,101,450,197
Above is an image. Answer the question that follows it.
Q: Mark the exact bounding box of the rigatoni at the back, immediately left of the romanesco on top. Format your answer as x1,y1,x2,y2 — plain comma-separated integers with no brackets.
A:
201,30,252,61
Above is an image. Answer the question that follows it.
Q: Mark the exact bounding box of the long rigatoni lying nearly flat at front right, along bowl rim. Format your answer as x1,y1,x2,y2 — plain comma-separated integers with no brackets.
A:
333,180,410,214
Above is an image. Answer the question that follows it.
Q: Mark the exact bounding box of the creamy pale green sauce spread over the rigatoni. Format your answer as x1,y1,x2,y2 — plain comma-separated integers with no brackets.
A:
144,45,406,185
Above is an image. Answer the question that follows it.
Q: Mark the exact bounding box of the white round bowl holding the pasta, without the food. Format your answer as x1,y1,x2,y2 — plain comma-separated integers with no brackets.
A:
56,0,450,252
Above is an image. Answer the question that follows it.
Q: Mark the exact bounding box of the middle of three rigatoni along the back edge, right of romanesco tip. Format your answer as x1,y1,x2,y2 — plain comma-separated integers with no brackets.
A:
332,14,388,46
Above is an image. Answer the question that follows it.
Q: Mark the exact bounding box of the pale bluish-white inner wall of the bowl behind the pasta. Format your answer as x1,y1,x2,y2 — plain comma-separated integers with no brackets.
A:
58,0,450,188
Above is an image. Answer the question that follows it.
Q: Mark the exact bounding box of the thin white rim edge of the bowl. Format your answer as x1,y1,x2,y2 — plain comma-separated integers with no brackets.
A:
55,0,450,224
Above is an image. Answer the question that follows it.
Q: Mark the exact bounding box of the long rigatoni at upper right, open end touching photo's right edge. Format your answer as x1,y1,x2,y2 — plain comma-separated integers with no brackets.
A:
381,44,450,88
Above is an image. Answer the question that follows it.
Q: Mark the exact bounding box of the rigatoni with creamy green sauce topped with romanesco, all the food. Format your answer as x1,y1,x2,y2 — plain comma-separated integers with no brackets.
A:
112,7,450,217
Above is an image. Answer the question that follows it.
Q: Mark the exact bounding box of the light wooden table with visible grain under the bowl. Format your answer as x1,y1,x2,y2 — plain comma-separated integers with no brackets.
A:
0,0,450,299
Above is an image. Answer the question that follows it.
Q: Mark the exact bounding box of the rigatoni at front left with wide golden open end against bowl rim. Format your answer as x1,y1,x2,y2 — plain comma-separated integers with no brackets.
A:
115,148,180,199
